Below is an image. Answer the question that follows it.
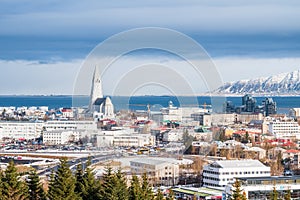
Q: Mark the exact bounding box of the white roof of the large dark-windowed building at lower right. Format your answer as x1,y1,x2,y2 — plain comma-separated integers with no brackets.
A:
213,160,267,168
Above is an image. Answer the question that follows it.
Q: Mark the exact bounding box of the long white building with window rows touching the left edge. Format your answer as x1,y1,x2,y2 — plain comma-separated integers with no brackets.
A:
0,122,43,139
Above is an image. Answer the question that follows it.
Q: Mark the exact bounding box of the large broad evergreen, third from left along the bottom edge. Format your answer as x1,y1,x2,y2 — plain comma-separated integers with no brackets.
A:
48,158,80,200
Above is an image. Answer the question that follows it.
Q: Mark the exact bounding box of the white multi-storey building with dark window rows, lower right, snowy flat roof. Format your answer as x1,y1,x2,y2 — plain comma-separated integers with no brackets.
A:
203,160,270,188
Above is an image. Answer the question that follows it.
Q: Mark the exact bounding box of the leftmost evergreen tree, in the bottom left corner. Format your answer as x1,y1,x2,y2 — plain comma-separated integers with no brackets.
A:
1,160,28,200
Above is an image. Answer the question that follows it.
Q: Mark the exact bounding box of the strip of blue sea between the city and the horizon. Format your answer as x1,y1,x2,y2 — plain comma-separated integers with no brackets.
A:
0,95,300,114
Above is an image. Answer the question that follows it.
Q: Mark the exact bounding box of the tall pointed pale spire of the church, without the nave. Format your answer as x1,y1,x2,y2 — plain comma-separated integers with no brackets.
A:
89,66,103,112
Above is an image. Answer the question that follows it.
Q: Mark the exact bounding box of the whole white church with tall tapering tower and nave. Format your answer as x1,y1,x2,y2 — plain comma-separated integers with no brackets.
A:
89,67,115,120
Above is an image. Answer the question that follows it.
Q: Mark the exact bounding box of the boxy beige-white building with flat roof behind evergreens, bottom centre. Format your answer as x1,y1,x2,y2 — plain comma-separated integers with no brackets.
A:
130,157,179,186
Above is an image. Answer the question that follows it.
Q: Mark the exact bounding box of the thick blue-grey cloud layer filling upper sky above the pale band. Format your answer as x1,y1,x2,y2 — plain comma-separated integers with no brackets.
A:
0,0,300,60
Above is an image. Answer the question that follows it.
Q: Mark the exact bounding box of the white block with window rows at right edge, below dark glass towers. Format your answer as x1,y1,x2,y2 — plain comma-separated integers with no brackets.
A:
269,120,300,139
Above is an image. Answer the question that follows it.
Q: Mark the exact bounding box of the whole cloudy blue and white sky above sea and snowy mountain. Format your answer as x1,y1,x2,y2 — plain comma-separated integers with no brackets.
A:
0,0,300,95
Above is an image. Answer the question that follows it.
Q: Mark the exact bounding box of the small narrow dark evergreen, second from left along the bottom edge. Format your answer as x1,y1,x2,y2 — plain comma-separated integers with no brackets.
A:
27,170,46,200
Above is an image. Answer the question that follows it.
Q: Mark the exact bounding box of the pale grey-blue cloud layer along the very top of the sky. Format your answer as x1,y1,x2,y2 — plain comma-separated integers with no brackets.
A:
0,0,300,37
